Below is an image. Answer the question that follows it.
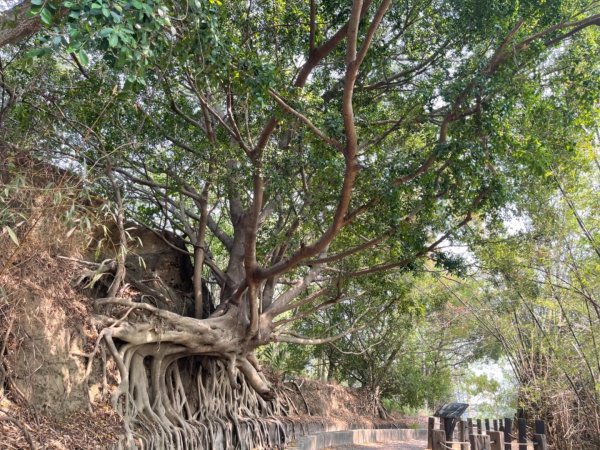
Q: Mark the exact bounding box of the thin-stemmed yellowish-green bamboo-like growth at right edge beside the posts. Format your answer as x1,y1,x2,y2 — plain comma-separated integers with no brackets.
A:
454,115,600,449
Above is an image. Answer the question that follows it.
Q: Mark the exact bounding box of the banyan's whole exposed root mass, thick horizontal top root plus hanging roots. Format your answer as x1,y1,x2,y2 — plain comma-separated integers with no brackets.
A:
99,299,286,449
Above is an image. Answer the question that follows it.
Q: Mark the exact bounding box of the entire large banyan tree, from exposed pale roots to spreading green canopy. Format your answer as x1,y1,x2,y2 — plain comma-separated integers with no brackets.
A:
0,0,600,448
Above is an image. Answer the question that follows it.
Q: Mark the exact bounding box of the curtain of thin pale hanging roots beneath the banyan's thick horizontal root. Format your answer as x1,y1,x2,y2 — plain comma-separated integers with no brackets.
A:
98,330,286,450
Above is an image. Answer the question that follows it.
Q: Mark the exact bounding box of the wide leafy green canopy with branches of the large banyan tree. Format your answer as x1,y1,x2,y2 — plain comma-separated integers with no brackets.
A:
5,1,599,331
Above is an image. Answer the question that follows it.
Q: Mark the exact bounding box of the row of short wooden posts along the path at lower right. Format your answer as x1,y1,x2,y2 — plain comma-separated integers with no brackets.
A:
427,417,548,450
